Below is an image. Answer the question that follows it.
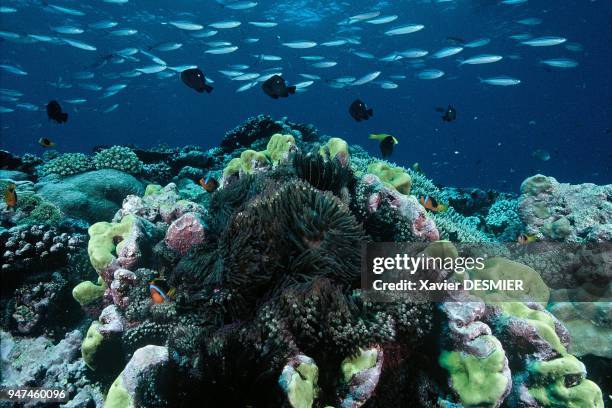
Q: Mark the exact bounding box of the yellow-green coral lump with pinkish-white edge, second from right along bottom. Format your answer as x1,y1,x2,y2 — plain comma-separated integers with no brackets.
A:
439,335,509,408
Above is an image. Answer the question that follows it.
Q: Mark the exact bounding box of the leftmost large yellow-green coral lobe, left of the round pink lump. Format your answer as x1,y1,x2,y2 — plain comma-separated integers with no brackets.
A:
87,215,135,272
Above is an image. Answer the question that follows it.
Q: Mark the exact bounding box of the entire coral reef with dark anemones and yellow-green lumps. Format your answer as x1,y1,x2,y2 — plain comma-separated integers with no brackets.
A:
0,116,611,408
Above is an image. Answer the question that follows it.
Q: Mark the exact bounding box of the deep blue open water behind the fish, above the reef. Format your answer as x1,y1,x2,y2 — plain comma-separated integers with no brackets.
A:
0,0,612,191
